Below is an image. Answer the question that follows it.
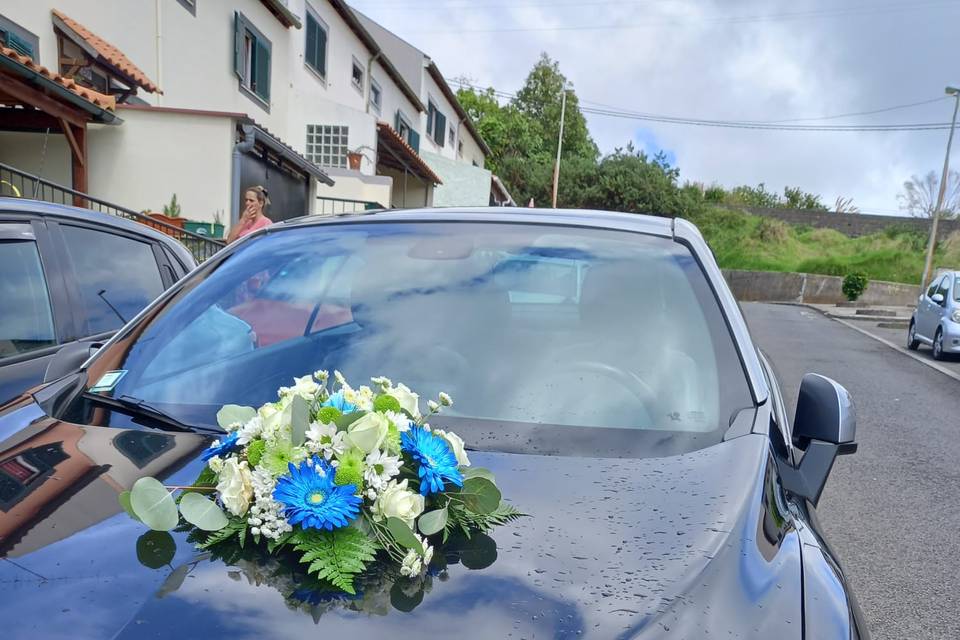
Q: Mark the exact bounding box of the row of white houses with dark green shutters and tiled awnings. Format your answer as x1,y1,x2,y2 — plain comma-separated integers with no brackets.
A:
0,0,491,228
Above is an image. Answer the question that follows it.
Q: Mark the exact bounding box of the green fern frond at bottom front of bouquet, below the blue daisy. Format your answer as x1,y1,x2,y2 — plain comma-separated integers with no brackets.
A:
293,527,378,594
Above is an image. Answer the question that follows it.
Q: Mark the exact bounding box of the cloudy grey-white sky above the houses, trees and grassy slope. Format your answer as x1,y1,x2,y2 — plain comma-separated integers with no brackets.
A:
352,0,960,214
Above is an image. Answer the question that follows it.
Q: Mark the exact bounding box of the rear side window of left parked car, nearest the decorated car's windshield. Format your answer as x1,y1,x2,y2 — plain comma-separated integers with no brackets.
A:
60,225,164,335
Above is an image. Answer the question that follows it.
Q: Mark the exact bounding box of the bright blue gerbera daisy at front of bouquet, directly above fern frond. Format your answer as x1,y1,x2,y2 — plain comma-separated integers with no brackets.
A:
273,456,362,531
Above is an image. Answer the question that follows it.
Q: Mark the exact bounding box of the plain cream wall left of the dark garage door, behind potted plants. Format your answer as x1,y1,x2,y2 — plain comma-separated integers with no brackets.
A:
87,109,235,224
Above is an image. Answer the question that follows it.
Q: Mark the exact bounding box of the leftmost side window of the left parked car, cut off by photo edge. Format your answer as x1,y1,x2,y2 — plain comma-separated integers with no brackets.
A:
0,240,57,358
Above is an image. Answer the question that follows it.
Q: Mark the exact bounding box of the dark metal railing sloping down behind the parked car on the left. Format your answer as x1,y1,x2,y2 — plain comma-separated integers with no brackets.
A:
0,162,225,262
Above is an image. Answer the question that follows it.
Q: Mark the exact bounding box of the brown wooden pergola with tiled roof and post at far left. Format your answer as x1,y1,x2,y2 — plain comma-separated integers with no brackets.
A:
0,46,122,193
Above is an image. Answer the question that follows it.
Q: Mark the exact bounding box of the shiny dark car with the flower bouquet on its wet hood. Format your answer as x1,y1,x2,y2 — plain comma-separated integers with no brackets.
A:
0,209,868,640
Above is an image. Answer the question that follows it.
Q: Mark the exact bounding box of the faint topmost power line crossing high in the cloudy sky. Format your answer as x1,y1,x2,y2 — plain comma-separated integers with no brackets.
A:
394,0,960,36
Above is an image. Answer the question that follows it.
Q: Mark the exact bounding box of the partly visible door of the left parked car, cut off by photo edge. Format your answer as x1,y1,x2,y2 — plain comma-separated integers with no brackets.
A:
0,217,72,404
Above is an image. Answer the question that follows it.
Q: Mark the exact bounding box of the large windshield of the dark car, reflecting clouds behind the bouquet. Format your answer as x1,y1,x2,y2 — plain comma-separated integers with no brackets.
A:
79,222,752,458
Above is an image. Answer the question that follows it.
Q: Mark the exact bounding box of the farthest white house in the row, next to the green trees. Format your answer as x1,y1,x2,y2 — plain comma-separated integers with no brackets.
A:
354,10,513,207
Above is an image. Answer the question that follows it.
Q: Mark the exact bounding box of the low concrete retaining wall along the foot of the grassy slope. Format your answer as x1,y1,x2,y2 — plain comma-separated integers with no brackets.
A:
723,269,920,306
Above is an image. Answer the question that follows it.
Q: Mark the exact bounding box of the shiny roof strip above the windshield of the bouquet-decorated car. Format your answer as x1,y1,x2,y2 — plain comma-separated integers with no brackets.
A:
278,207,674,238
